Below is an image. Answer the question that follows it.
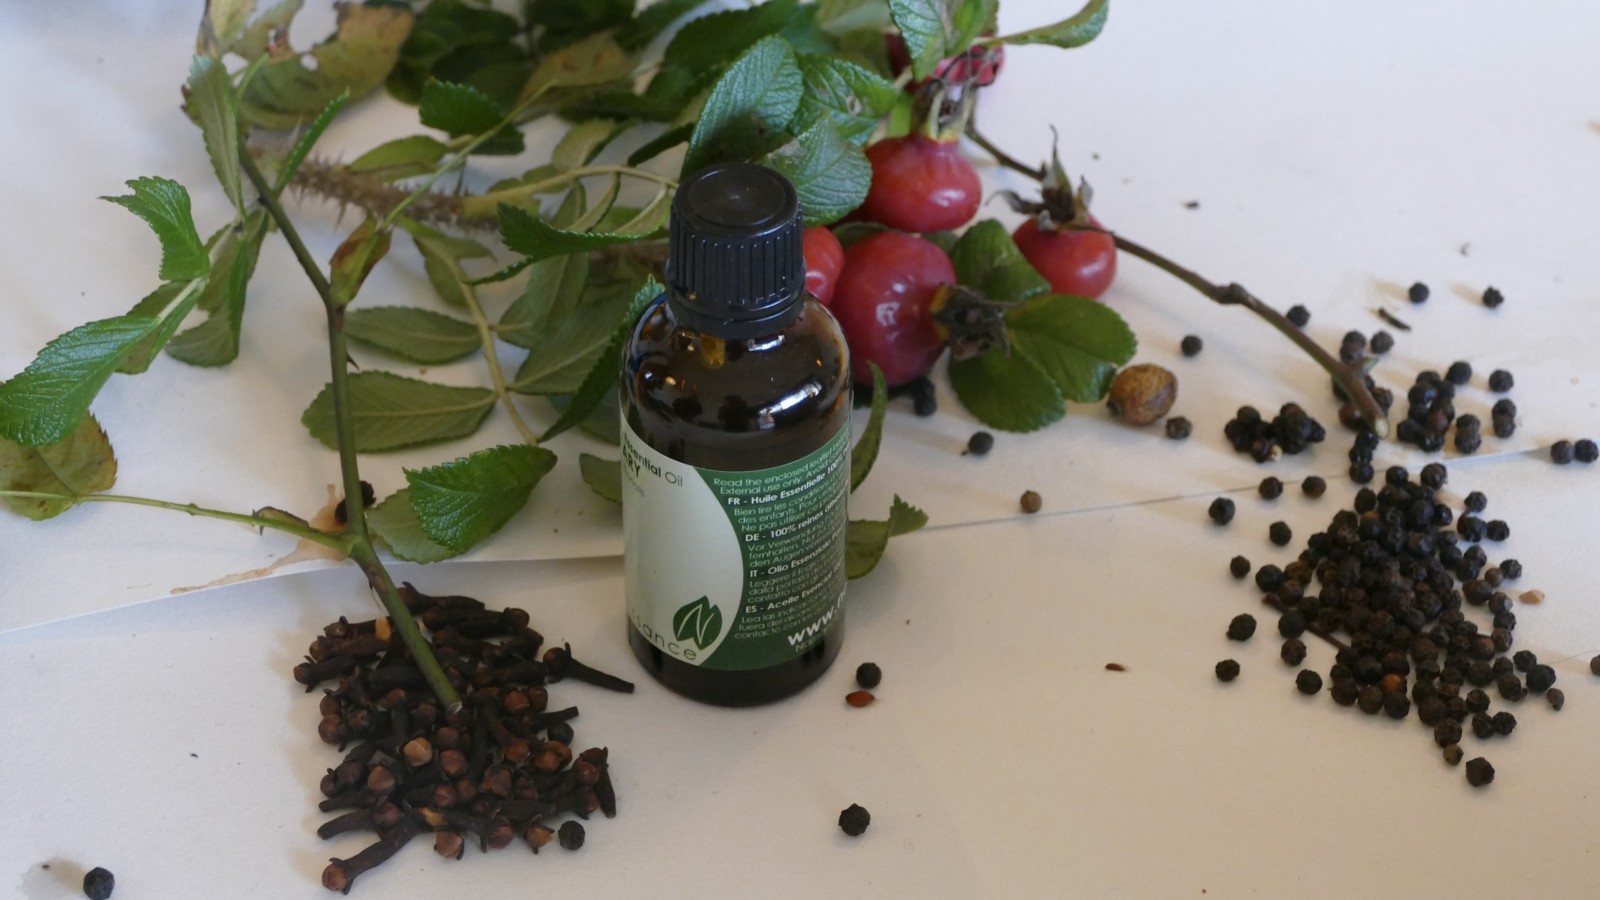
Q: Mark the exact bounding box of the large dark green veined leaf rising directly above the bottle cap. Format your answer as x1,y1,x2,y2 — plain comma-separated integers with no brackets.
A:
683,36,805,173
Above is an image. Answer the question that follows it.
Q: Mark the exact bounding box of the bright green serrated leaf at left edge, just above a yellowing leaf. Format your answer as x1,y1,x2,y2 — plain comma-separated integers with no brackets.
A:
0,315,160,447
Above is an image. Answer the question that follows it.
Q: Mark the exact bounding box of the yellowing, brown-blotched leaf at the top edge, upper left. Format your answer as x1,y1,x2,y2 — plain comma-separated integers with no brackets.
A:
240,2,414,128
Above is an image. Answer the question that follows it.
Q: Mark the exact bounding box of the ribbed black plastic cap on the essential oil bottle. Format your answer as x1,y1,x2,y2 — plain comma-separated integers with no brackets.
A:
667,163,805,340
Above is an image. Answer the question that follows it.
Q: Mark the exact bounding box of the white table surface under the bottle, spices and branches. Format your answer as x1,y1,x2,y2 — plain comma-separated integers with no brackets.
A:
0,0,1600,900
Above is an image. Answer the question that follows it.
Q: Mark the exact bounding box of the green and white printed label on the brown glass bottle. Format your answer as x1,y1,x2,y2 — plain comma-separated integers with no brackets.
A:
622,420,850,669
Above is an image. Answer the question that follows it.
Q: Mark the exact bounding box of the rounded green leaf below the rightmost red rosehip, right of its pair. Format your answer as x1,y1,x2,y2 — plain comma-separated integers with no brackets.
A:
1005,295,1138,404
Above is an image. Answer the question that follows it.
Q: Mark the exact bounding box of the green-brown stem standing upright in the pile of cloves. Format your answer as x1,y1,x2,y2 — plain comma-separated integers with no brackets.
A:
238,149,461,713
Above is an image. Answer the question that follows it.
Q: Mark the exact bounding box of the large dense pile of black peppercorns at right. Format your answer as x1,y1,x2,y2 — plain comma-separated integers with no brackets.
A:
1218,454,1565,786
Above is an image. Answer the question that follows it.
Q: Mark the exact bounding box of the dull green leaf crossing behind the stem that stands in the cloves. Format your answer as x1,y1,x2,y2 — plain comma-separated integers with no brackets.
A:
301,370,494,453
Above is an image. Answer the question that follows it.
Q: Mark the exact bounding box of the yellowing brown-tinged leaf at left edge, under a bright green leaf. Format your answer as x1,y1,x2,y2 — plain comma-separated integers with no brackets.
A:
0,415,117,520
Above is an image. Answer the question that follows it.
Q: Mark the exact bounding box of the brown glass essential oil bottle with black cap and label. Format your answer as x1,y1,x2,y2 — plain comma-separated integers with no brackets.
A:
621,163,851,706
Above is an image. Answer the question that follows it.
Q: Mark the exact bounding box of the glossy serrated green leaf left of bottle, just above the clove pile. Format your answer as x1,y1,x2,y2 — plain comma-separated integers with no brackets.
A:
405,444,555,551
